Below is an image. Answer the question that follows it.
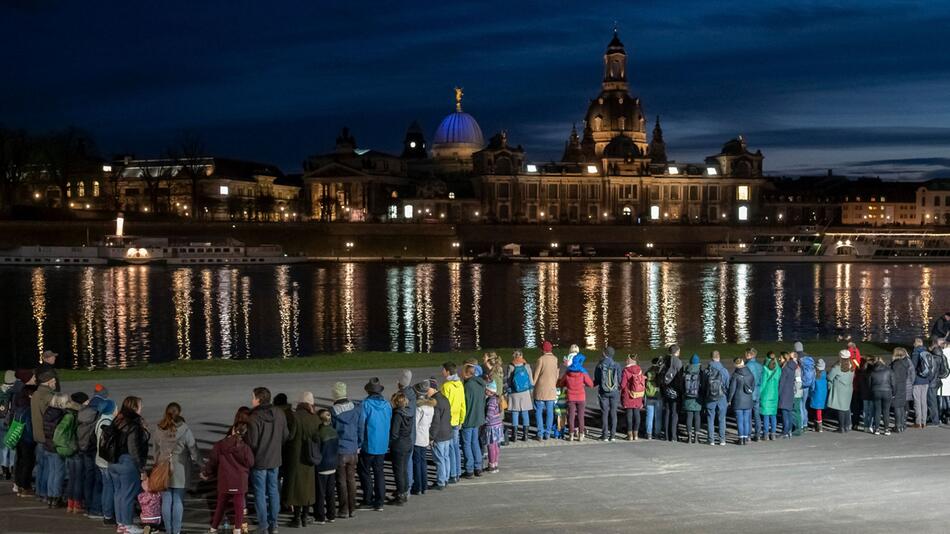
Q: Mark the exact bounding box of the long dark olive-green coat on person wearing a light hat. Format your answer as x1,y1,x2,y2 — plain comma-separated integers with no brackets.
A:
281,407,321,506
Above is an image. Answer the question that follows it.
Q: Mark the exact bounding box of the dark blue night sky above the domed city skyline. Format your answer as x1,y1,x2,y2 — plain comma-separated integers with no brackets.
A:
0,0,950,178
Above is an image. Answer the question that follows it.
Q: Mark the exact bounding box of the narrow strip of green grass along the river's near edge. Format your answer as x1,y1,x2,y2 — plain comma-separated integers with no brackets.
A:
60,340,897,381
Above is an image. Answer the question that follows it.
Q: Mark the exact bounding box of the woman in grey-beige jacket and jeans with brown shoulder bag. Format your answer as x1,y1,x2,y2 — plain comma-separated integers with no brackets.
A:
155,402,201,534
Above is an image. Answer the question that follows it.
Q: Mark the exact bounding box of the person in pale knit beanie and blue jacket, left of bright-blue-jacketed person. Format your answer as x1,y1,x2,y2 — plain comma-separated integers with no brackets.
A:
330,382,363,518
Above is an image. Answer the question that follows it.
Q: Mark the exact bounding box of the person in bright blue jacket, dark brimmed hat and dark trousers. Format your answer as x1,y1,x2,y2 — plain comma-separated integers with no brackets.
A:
358,377,393,511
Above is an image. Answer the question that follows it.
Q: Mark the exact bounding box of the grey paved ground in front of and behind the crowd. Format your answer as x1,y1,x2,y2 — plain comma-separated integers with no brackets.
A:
0,370,950,534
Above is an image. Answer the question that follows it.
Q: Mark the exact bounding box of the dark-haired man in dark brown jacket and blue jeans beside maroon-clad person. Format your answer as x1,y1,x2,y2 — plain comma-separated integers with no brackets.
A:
245,387,290,531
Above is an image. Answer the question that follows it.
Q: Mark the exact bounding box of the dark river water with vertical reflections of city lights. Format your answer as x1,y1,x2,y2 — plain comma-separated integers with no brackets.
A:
0,263,950,367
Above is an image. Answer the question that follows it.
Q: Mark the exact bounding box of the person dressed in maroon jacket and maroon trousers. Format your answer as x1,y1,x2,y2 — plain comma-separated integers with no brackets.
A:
201,422,254,534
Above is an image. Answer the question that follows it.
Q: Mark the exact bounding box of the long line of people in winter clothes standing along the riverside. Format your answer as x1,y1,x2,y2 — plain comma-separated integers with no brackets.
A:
0,336,950,534
